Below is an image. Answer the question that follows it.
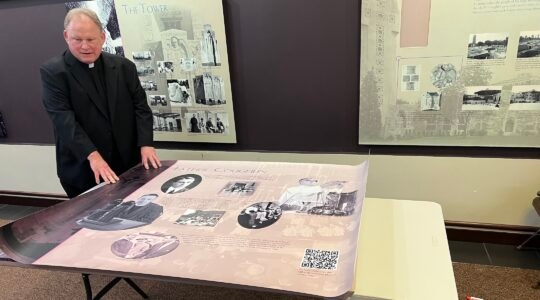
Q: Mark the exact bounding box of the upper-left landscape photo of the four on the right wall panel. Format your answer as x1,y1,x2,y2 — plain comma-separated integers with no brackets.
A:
467,32,508,59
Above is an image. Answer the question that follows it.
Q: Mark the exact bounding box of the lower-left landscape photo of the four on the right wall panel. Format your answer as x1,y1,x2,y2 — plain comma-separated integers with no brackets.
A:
461,86,502,110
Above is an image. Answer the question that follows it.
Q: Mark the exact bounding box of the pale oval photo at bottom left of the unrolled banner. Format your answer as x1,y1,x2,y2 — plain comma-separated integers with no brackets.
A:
111,232,180,259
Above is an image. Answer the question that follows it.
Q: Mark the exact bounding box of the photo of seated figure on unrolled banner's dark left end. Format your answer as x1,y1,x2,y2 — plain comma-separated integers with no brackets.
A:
77,194,163,231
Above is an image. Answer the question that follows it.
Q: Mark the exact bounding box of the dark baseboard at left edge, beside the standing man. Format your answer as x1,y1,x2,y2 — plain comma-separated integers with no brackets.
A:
0,190,69,207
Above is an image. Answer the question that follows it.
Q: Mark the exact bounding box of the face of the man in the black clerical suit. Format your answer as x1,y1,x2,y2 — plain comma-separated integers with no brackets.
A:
64,15,105,64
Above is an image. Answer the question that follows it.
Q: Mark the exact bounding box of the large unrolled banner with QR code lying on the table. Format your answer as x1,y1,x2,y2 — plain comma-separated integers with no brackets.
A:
0,161,368,297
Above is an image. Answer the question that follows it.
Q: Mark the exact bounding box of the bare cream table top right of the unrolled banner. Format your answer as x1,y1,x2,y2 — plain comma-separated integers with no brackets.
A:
352,198,458,300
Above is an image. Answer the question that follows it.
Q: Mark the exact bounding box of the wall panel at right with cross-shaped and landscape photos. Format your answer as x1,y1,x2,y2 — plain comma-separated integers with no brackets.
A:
359,0,540,147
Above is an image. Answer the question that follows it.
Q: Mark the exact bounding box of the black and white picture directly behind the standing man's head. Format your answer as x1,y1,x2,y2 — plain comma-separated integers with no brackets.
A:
66,0,124,56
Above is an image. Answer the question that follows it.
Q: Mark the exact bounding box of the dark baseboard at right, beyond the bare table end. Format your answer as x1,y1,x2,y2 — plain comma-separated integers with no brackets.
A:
445,221,540,247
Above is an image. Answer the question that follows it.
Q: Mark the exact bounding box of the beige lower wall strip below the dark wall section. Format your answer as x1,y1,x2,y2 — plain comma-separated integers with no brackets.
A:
0,145,540,226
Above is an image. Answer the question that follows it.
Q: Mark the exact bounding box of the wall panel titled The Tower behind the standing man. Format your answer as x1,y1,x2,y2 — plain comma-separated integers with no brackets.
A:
66,0,236,143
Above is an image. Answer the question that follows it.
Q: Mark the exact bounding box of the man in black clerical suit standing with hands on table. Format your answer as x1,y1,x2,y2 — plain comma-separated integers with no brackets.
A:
40,8,161,198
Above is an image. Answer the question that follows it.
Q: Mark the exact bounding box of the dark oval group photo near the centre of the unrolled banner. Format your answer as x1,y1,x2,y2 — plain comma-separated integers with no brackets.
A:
238,202,281,229
